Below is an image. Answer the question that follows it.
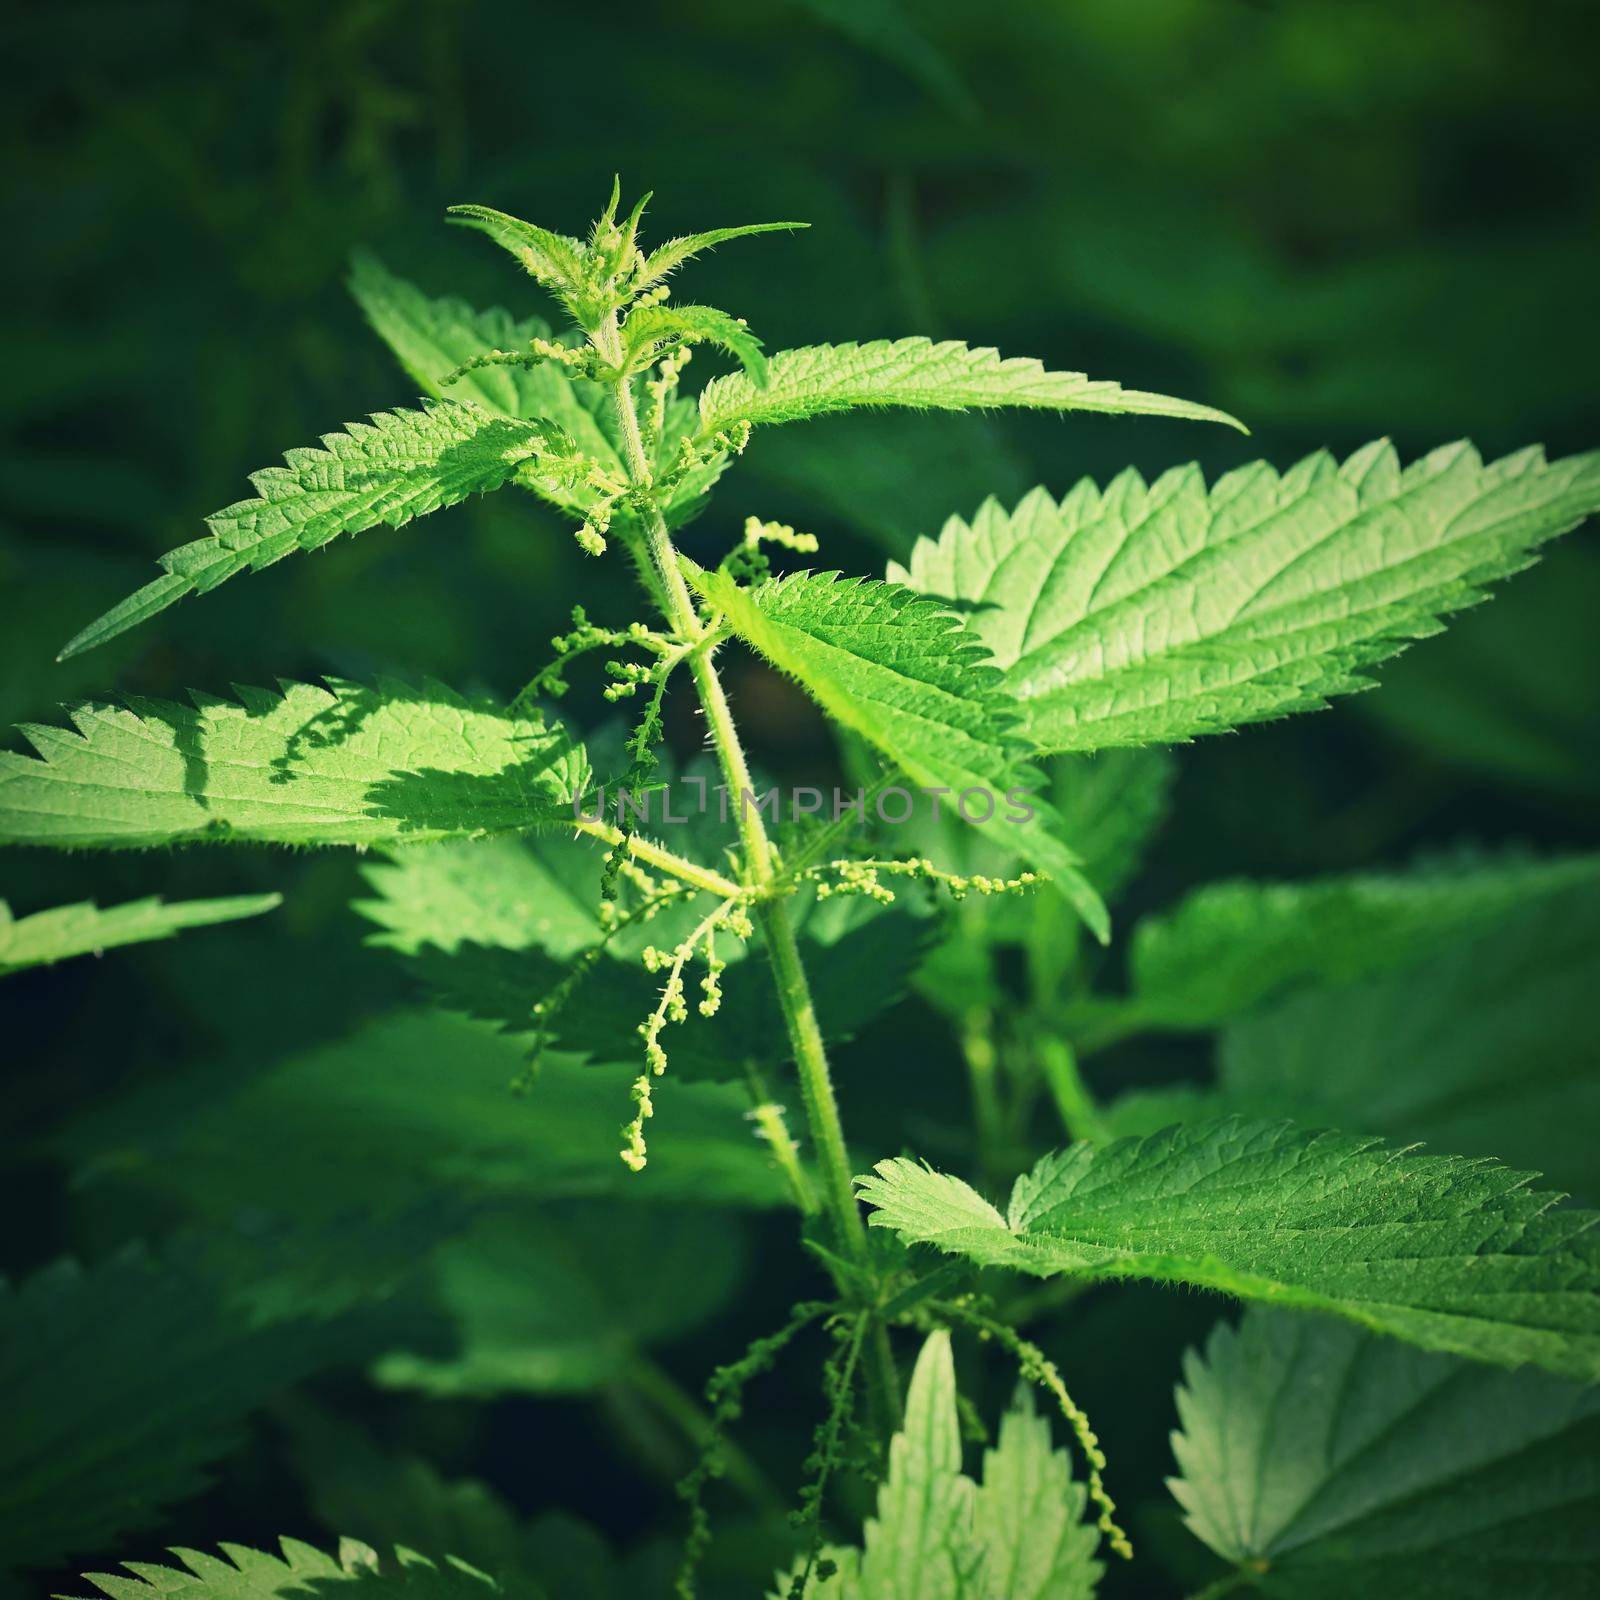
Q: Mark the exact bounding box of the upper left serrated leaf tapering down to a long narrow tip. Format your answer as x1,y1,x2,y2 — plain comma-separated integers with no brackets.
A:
59,400,582,661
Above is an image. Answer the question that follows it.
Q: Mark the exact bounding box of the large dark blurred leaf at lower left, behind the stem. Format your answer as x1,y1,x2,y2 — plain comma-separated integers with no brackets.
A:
62,1011,786,1226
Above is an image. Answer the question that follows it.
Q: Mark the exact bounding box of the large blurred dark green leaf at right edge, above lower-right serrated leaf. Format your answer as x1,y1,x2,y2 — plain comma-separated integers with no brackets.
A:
1107,861,1600,1198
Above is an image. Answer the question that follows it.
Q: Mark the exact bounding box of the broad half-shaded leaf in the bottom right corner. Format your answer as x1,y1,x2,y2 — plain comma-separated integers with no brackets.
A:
1171,1309,1600,1600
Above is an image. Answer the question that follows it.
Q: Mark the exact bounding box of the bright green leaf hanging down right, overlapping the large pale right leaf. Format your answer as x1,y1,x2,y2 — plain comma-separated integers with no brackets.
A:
683,562,1109,939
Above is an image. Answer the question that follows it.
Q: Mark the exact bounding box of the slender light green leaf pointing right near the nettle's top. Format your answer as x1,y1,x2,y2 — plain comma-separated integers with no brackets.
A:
699,339,1242,437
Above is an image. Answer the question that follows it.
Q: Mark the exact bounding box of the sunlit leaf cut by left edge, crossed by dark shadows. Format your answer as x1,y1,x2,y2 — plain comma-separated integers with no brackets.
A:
0,682,587,850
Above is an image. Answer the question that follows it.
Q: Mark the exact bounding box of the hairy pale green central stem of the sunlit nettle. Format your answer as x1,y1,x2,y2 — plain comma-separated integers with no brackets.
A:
594,334,899,1424
